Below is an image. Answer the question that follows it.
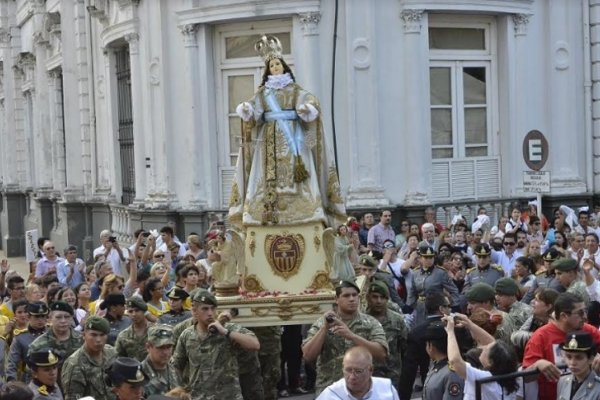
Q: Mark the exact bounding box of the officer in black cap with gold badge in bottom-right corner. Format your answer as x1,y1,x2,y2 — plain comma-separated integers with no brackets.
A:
557,332,600,400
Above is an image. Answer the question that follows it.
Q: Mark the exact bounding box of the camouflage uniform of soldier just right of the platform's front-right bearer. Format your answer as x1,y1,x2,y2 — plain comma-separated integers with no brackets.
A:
373,310,408,387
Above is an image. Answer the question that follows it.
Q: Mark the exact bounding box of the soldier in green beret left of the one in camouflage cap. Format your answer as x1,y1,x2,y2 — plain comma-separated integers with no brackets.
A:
61,315,117,400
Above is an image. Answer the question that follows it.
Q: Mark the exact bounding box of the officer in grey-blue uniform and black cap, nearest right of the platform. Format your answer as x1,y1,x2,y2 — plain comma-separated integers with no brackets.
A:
406,246,459,326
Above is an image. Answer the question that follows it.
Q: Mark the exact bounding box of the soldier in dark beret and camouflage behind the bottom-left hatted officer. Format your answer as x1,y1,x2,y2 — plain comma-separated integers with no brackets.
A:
27,301,83,374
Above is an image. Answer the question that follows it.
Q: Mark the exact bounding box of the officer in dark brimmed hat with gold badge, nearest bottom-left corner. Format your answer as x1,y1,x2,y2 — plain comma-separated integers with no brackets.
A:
27,349,63,400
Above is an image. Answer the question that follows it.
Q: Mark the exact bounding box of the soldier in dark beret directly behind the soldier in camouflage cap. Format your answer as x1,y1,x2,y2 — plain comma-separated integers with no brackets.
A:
115,296,150,362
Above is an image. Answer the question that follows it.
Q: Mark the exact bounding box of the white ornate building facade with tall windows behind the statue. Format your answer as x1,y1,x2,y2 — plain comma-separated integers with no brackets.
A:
0,0,600,256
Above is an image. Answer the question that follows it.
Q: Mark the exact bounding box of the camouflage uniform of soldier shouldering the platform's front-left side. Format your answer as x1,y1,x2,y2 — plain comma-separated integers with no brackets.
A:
171,323,254,400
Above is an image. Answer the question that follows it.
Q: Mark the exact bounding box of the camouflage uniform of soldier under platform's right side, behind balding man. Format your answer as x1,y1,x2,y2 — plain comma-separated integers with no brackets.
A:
302,312,389,394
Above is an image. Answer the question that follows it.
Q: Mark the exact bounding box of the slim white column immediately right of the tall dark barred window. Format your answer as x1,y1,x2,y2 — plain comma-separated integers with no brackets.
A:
125,33,146,206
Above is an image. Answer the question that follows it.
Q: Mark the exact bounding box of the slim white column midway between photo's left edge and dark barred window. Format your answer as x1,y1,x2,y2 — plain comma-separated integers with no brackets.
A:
47,68,66,192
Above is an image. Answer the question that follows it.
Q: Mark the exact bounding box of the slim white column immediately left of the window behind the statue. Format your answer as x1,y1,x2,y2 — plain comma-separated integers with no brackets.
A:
181,24,210,209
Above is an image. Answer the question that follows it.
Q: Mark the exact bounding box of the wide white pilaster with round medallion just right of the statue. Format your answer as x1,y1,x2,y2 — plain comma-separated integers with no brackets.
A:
345,0,389,208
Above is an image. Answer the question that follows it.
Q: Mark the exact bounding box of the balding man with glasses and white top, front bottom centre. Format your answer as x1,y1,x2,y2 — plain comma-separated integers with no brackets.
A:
317,346,399,400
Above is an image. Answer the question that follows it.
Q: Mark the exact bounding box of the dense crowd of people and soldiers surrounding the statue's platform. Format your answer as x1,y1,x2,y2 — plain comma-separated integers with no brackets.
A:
0,204,600,400
